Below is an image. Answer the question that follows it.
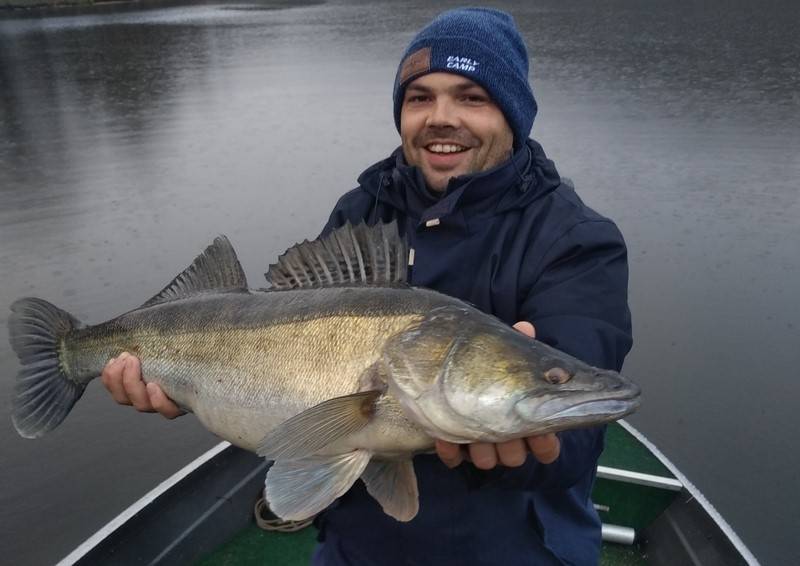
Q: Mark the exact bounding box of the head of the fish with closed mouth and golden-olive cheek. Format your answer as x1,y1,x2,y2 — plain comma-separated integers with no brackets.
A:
387,305,640,442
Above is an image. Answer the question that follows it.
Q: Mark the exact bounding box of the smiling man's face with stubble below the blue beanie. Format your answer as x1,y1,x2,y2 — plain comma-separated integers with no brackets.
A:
400,73,514,191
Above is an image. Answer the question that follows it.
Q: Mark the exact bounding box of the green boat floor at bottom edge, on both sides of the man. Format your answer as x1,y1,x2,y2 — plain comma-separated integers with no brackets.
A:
195,525,647,566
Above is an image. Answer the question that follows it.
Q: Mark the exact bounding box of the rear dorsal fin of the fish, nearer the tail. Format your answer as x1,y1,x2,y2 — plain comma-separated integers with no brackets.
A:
142,236,247,307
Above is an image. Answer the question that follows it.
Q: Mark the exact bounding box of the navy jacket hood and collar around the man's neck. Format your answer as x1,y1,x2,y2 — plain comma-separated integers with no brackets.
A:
358,139,561,223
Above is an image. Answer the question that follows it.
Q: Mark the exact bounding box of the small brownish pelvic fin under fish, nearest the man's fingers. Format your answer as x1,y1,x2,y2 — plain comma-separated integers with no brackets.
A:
361,460,419,522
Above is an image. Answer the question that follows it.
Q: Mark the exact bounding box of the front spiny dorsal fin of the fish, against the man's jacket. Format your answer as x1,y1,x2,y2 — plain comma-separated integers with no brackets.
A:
265,220,408,290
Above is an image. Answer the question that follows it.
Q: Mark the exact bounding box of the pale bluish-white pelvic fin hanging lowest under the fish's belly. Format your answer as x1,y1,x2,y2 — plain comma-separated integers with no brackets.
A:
264,450,371,521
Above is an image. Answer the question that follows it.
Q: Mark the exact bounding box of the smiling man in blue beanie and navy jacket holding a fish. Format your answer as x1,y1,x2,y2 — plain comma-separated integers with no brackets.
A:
103,9,631,565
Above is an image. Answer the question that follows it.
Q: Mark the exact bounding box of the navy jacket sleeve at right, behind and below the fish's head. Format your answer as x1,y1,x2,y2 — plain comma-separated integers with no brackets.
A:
488,219,632,489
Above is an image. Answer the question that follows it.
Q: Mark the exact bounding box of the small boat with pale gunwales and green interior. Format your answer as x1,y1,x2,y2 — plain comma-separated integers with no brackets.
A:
54,420,758,566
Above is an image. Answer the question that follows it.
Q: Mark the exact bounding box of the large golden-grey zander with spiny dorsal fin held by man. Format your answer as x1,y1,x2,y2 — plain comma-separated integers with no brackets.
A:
9,224,639,521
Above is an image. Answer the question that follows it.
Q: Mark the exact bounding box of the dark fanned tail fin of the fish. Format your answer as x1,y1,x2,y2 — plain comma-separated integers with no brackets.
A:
8,298,86,438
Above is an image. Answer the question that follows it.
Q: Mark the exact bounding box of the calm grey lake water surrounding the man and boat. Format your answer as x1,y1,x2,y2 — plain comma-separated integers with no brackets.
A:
0,0,800,564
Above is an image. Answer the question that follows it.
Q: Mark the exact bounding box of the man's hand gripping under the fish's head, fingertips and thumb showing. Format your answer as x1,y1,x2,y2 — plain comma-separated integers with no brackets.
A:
436,322,561,470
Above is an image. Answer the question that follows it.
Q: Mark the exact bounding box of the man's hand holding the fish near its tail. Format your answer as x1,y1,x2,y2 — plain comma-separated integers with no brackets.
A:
101,352,185,419
